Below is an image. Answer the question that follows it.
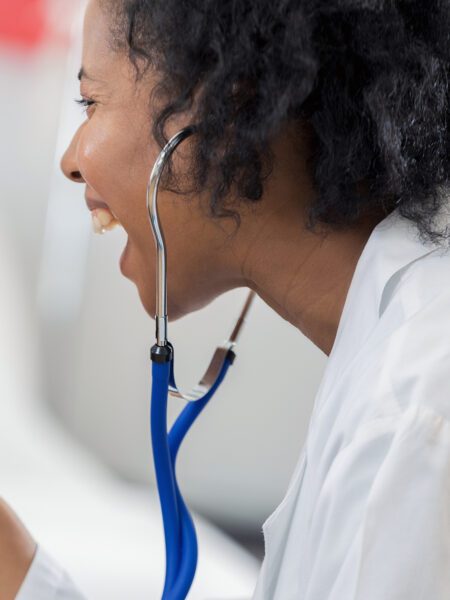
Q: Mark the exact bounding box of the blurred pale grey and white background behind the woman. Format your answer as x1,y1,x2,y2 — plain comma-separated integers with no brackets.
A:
0,0,325,599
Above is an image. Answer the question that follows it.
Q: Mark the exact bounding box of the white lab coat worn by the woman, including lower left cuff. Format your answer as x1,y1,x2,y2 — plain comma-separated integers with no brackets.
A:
16,207,450,600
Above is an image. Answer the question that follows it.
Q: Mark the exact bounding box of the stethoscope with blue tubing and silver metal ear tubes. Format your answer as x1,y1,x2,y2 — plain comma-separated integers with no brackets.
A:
147,126,255,600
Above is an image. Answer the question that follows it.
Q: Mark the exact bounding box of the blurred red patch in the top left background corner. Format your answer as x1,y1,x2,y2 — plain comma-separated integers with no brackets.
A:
0,0,46,48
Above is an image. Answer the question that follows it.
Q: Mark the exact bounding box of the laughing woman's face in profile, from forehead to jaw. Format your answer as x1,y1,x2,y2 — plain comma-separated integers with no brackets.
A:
62,0,245,320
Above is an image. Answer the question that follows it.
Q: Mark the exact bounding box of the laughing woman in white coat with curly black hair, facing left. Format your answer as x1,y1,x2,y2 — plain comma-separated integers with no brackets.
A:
1,0,450,600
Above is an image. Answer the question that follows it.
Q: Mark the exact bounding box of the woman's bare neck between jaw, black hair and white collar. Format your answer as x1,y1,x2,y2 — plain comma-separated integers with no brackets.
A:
236,126,382,355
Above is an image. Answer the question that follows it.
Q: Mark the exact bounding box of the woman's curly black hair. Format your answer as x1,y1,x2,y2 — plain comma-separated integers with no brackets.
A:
108,0,450,240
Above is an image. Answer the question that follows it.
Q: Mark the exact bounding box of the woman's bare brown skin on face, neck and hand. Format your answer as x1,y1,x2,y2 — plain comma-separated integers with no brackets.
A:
0,0,382,600
